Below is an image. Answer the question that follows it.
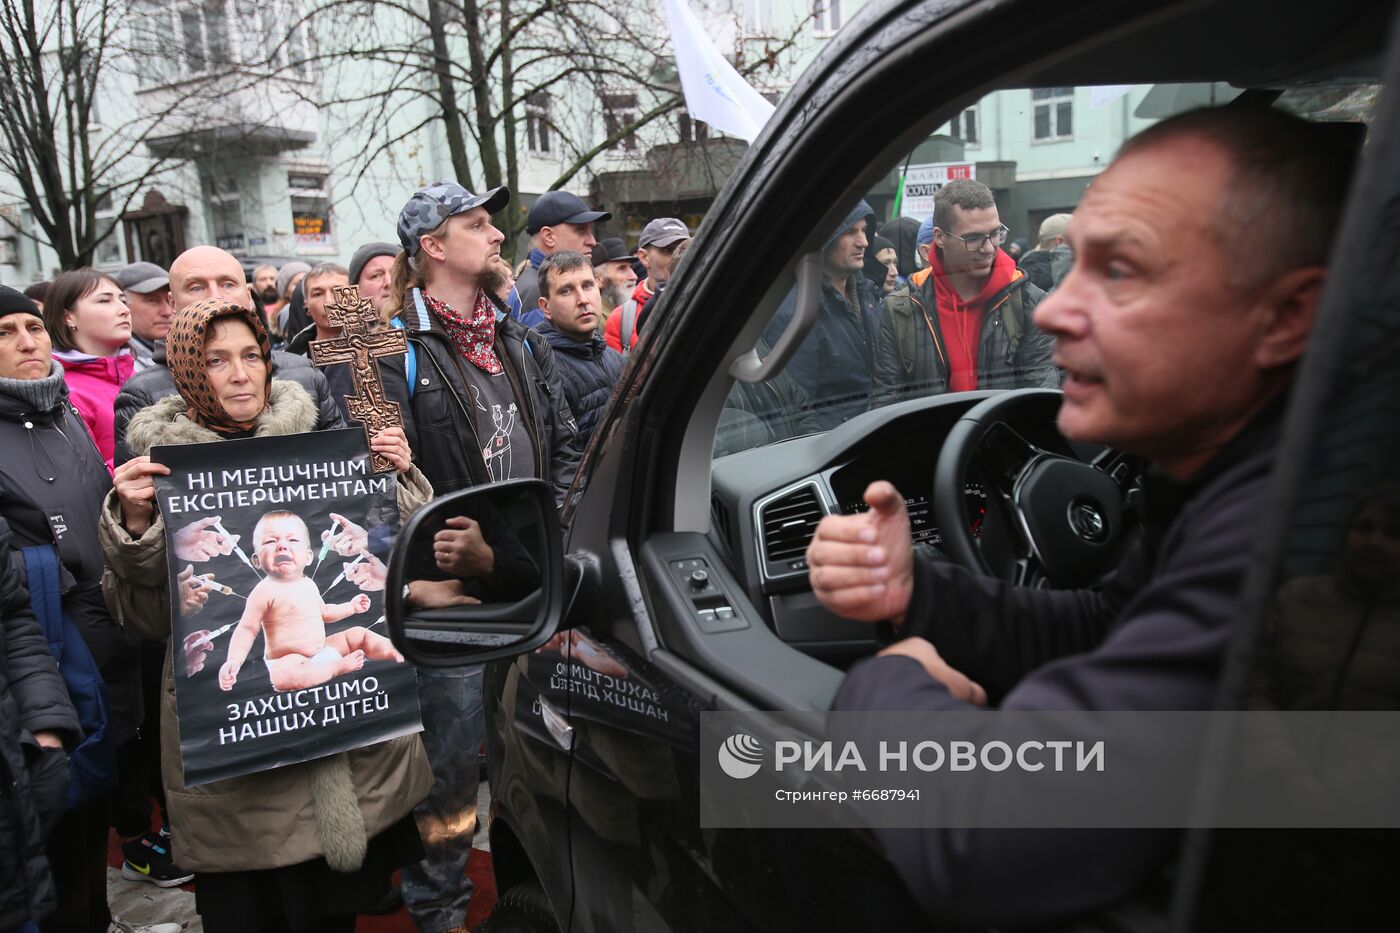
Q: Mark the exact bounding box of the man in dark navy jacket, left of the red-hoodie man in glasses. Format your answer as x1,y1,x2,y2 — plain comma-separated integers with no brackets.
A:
763,200,878,430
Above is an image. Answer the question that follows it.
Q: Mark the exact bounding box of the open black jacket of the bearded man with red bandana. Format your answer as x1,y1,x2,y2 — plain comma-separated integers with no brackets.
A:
397,298,582,504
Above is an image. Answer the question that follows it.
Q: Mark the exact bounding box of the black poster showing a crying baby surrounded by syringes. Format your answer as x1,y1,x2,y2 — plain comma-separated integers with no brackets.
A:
151,429,421,787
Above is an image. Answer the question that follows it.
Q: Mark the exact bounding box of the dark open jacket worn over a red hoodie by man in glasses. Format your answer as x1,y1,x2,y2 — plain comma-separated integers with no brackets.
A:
871,264,1060,406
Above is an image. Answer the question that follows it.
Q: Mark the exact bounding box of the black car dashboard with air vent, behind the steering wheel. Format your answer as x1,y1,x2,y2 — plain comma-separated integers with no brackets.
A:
710,391,1064,665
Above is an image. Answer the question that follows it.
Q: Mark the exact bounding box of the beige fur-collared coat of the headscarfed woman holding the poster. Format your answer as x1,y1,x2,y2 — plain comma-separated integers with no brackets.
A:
98,380,433,871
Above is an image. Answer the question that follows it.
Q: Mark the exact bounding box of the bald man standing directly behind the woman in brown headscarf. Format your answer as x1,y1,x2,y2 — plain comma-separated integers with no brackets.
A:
113,247,344,467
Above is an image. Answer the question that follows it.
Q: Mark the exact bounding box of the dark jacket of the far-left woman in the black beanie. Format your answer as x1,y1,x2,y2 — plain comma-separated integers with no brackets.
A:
0,369,141,745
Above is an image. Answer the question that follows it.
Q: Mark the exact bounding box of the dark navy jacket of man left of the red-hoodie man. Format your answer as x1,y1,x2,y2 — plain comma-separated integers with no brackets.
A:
763,273,878,431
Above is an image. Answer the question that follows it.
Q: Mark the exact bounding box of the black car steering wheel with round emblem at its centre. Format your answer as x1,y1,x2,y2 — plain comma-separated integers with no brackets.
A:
932,389,1141,587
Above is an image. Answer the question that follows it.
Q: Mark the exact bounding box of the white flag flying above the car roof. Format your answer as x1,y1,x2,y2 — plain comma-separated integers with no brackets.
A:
666,0,774,143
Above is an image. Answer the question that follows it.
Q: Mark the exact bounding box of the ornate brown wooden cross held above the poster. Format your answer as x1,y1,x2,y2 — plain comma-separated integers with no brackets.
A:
311,286,409,474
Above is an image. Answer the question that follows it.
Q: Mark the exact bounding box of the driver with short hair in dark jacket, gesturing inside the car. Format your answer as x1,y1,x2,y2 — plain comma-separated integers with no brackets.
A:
808,109,1355,926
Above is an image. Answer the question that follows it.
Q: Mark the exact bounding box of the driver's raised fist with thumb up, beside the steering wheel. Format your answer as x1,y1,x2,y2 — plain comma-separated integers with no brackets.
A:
806,479,914,625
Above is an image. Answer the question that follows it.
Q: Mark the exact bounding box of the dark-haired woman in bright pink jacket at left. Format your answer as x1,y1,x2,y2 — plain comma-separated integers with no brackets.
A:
43,269,136,471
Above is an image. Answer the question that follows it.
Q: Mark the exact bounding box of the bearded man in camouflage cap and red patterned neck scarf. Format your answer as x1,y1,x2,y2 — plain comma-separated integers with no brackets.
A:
384,181,579,933
